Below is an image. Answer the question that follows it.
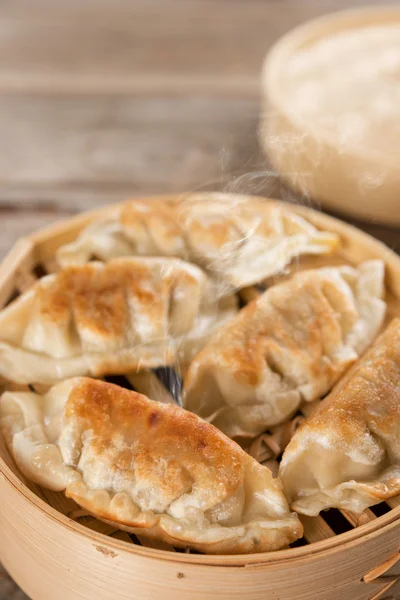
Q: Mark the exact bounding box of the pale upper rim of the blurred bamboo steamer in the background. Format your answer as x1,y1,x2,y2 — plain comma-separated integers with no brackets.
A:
261,4,400,169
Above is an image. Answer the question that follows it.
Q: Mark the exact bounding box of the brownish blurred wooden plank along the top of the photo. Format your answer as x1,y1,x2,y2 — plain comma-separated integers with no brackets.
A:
0,0,378,95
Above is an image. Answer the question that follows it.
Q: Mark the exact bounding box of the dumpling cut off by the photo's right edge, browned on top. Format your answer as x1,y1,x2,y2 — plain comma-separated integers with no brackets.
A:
279,319,400,516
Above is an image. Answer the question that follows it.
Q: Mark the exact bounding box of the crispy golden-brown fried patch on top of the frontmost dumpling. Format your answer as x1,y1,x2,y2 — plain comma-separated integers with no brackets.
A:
65,379,244,505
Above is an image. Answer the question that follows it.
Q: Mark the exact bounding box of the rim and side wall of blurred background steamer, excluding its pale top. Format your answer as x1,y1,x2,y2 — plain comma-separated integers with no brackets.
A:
259,6,400,226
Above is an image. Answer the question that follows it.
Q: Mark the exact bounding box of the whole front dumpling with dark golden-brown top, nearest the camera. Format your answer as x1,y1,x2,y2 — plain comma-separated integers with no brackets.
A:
0,378,302,554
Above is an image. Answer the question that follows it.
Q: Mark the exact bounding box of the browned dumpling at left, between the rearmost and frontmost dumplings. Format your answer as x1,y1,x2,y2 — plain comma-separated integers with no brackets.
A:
0,257,237,384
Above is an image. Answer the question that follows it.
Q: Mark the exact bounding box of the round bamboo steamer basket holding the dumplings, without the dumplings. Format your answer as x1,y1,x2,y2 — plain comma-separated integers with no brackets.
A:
0,193,400,600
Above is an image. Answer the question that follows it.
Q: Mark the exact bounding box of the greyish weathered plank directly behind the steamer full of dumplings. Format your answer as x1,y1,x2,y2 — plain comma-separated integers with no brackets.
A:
0,95,259,211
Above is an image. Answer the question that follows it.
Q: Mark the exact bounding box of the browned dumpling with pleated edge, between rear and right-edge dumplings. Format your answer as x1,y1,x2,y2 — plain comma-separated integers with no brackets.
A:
184,260,386,437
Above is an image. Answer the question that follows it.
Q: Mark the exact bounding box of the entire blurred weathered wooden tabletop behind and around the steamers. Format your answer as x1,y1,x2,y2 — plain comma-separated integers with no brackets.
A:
0,0,400,600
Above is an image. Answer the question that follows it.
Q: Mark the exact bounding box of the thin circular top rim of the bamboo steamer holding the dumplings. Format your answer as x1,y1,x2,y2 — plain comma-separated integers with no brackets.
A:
0,192,400,567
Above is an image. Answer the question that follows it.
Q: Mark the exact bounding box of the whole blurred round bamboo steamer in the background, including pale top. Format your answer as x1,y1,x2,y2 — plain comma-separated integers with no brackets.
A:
260,6,400,225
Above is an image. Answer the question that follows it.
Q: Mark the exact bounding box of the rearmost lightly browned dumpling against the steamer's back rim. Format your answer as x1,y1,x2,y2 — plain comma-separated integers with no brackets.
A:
57,193,338,289
